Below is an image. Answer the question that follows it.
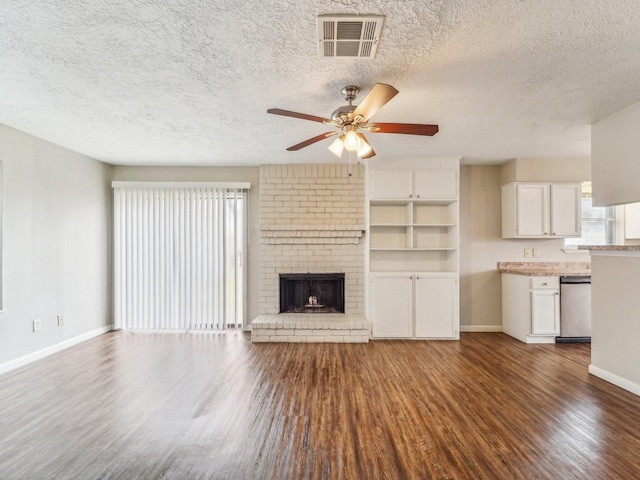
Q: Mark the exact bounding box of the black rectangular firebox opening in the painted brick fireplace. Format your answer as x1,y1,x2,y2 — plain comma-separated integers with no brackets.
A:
280,273,344,313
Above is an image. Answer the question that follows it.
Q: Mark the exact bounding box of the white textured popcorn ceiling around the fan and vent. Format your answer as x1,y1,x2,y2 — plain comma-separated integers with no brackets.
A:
0,0,640,165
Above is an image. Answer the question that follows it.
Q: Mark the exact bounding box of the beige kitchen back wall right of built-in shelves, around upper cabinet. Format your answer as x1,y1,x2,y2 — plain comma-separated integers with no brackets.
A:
460,160,590,331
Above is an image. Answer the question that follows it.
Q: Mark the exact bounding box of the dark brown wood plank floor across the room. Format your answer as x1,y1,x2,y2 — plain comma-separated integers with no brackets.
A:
0,332,640,480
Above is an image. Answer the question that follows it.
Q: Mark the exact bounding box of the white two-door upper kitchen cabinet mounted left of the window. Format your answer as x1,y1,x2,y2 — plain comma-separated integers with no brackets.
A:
502,182,582,238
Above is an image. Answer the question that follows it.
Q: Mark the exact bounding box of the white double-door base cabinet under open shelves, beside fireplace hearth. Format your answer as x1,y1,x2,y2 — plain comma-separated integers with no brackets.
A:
371,272,460,340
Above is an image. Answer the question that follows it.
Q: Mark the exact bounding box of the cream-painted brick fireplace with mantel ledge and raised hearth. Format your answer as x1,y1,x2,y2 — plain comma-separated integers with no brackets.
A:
252,164,368,341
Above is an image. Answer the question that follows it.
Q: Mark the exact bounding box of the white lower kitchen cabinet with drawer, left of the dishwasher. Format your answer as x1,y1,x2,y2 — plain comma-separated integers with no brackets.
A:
502,273,560,343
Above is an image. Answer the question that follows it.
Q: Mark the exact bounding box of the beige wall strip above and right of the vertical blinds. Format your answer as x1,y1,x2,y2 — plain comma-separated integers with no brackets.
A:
113,166,260,323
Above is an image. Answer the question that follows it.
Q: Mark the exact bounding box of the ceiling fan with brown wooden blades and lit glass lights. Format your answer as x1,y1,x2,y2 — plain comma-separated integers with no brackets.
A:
267,83,438,159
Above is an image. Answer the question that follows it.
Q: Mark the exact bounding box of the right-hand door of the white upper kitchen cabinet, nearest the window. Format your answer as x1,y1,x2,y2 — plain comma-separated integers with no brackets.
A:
550,184,582,237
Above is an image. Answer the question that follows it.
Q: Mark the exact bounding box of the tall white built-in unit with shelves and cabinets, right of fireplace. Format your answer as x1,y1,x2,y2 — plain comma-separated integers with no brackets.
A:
368,166,460,339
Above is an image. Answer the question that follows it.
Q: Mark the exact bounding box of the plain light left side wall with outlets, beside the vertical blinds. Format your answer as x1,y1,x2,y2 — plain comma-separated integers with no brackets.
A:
0,125,111,365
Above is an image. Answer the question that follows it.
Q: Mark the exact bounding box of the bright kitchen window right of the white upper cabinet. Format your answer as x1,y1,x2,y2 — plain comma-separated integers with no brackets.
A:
564,182,618,250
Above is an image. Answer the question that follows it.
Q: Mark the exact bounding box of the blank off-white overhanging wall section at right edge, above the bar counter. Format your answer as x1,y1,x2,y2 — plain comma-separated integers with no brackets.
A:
591,103,640,206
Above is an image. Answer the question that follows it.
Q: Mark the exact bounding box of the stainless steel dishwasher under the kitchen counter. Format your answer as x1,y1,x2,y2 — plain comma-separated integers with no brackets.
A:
556,276,591,343
